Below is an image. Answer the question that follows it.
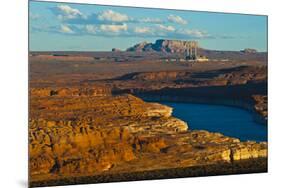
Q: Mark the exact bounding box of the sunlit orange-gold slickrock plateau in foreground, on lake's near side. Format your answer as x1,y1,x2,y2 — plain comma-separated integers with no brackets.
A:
29,91,267,186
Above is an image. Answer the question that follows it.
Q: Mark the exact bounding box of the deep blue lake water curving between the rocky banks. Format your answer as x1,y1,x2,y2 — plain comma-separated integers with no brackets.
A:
161,102,267,141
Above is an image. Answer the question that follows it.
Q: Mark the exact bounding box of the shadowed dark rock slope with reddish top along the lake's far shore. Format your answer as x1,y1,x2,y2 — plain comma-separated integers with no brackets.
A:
111,66,267,124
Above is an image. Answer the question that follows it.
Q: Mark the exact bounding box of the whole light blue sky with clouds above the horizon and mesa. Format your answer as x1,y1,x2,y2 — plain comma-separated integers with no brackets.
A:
29,1,267,51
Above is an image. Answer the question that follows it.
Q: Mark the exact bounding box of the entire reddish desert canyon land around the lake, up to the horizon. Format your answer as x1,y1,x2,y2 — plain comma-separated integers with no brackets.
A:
29,43,268,186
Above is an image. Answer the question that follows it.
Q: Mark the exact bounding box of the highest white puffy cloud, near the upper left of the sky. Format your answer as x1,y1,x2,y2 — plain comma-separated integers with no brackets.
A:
57,5,85,19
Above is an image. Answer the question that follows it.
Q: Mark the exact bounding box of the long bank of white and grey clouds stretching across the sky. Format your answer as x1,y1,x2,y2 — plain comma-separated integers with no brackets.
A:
32,4,232,40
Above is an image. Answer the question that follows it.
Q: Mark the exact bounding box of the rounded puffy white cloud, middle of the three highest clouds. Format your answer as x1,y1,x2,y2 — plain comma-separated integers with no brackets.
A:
98,10,129,22
